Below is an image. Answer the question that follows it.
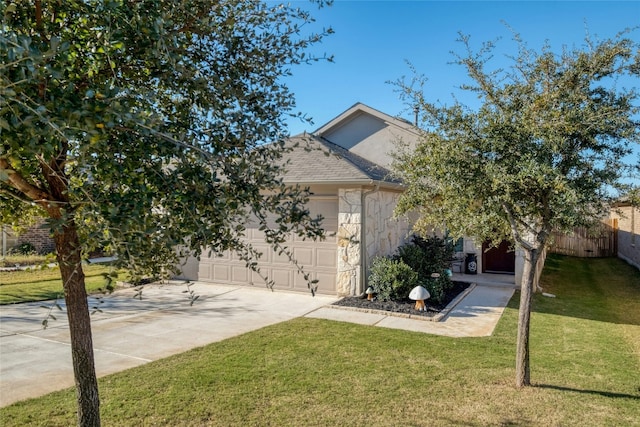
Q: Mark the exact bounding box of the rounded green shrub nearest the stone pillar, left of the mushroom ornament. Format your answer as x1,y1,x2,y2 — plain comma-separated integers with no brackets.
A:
369,257,420,301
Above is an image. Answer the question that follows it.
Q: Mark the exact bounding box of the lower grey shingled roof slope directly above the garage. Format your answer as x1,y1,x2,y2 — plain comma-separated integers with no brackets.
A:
283,134,402,187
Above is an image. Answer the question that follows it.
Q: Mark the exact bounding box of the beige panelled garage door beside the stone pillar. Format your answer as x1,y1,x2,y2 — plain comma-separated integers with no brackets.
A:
198,197,338,295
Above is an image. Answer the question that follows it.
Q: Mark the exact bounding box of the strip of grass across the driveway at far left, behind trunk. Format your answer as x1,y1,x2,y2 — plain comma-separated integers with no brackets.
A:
0,264,124,305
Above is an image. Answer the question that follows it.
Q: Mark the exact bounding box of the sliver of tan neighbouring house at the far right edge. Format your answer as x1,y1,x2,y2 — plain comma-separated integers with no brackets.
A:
609,199,640,268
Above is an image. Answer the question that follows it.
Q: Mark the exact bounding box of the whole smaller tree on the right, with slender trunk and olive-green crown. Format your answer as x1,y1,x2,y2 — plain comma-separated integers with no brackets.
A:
395,32,640,387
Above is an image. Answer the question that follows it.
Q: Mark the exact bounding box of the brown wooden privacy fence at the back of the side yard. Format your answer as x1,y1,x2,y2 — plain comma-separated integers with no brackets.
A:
549,219,618,258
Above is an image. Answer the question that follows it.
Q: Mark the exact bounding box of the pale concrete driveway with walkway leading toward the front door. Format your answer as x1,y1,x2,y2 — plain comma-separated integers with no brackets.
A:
0,283,513,407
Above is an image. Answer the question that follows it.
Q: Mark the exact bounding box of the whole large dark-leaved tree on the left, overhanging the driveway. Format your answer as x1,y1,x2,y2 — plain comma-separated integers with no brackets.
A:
0,0,331,426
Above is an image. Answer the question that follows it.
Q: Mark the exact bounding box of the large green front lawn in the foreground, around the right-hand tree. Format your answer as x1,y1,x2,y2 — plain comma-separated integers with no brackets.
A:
0,256,640,426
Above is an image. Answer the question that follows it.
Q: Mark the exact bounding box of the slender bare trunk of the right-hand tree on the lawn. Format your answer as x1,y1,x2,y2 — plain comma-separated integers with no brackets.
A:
516,249,540,387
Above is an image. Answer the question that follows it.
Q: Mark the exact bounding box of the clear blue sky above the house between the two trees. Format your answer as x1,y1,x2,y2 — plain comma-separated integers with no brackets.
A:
286,0,640,135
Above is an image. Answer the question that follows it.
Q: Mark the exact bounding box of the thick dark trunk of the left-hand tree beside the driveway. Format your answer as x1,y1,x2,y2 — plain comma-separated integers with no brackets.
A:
54,220,100,427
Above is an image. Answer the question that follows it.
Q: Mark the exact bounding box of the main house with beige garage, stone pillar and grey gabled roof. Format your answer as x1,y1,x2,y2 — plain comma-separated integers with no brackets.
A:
181,103,521,295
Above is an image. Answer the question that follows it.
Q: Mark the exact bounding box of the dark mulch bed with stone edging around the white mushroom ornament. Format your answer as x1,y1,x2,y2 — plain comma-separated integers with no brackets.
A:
333,282,470,317
